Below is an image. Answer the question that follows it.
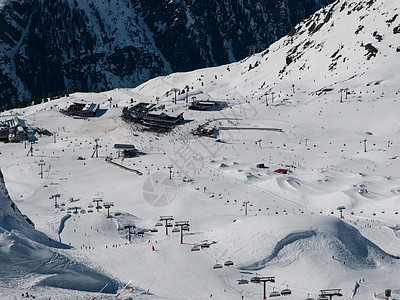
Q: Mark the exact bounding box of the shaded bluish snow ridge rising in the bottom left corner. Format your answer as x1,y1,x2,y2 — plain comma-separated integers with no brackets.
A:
0,170,118,293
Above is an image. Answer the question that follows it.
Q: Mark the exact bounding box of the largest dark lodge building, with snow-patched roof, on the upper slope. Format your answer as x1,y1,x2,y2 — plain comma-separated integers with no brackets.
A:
122,102,184,129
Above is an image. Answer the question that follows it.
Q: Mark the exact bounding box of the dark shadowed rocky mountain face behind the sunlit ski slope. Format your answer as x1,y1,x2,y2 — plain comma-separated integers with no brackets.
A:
0,0,333,106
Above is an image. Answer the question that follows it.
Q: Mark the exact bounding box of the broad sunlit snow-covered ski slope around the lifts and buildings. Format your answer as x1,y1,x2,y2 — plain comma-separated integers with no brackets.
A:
0,0,400,300
